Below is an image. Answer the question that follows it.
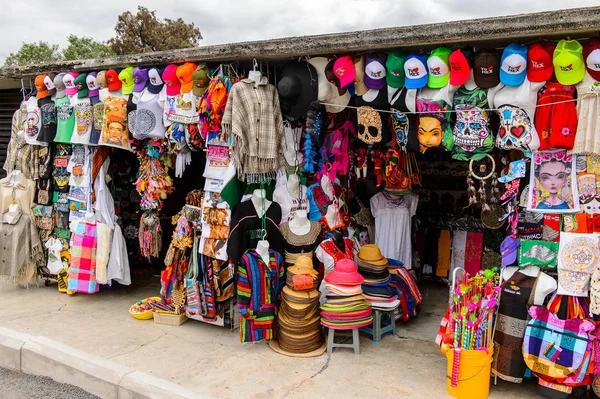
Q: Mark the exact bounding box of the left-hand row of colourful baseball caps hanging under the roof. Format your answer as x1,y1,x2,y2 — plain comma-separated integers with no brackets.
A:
35,62,210,98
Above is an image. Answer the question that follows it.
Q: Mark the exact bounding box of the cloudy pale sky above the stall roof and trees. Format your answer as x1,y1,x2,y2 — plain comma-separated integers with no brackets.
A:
0,0,599,63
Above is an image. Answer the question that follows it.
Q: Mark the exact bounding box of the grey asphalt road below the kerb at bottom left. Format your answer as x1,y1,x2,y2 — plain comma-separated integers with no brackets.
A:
0,367,99,399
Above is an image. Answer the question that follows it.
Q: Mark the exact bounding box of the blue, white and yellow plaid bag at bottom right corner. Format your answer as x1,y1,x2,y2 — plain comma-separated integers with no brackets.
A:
523,306,595,378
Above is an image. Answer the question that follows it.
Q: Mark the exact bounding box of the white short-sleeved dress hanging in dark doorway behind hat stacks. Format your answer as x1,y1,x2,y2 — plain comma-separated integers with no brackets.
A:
371,191,419,270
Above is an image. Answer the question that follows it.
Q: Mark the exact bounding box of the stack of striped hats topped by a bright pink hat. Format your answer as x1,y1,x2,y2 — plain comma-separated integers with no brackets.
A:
321,259,373,330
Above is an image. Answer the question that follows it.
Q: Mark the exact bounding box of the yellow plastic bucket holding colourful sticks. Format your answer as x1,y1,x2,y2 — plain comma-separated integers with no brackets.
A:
446,347,494,399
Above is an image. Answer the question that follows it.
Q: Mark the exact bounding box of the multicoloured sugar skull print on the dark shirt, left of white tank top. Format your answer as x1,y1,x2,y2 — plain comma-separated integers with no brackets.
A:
453,104,490,152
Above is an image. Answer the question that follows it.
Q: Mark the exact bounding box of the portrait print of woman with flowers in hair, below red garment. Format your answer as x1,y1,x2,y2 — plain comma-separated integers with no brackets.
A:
528,150,579,213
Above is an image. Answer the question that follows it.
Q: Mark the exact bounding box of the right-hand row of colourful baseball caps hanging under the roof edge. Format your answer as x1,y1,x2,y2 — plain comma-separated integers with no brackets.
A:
330,38,600,90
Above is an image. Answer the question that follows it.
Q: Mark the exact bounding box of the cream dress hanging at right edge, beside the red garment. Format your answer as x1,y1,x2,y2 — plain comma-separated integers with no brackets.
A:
571,71,600,155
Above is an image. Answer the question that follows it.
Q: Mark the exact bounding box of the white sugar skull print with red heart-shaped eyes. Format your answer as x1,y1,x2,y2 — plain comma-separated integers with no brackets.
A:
496,105,532,151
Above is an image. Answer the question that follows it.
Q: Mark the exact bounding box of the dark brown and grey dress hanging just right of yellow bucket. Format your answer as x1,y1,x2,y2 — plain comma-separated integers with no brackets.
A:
492,271,541,384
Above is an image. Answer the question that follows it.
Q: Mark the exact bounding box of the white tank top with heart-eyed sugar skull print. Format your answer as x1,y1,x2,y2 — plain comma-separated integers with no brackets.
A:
490,79,545,155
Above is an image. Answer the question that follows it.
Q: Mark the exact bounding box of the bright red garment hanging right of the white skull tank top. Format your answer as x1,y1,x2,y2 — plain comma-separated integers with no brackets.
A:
535,82,577,150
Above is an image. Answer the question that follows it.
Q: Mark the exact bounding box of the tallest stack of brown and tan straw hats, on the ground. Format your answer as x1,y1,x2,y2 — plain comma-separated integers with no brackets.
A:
271,256,325,356
